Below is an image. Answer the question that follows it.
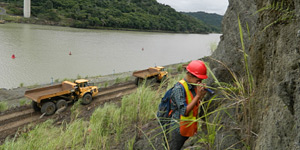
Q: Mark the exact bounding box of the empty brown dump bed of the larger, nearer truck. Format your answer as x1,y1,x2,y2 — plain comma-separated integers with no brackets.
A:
25,81,76,103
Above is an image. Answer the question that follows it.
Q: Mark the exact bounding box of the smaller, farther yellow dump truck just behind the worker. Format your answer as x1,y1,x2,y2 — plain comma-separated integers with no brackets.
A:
132,66,168,85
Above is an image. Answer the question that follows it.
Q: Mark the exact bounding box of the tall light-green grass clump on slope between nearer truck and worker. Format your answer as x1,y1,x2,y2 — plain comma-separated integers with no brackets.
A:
86,81,160,149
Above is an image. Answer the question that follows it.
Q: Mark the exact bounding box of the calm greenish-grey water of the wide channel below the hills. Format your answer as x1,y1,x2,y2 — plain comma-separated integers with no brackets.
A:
0,24,220,88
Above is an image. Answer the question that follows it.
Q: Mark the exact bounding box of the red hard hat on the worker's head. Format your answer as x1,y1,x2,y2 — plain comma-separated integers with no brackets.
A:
186,60,207,79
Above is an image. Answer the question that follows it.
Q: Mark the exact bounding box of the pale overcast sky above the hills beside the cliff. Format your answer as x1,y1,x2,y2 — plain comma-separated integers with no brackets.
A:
157,0,228,15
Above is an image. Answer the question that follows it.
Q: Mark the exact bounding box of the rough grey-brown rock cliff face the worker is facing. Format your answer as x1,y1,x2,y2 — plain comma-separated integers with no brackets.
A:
210,0,300,150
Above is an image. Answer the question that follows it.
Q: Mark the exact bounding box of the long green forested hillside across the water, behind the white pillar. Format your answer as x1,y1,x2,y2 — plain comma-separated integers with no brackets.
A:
0,0,214,33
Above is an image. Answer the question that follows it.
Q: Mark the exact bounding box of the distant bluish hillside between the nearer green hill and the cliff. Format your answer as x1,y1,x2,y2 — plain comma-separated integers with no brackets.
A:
183,11,223,33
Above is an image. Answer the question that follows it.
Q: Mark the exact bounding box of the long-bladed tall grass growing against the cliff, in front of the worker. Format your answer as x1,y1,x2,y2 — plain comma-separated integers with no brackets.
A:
192,17,255,149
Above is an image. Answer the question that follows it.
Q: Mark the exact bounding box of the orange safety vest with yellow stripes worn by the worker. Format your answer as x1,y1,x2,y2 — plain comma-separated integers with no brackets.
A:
179,79,199,137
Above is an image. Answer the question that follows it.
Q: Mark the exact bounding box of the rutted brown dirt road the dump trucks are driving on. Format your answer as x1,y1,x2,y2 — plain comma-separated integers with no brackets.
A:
0,82,137,144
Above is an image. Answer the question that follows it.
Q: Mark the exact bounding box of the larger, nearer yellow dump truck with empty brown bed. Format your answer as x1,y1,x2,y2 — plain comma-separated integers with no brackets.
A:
25,79,98,115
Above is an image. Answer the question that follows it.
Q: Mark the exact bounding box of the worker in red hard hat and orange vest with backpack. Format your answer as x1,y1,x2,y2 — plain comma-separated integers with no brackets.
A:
168,60,207,150
